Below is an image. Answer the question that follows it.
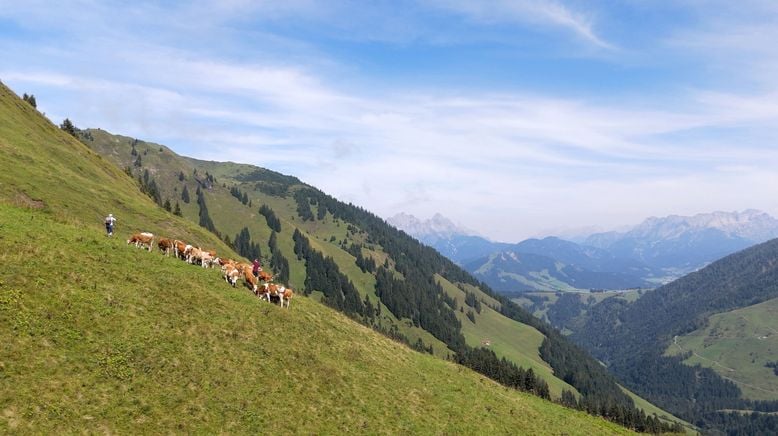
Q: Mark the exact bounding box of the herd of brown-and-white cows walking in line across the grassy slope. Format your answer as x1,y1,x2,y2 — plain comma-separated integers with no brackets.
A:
127,232,294,309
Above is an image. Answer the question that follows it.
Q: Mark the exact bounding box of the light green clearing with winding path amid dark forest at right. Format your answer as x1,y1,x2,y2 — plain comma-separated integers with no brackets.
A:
666,298,778,400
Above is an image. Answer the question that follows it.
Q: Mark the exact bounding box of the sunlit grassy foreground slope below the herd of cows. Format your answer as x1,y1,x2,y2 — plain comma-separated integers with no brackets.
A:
0,204,627,435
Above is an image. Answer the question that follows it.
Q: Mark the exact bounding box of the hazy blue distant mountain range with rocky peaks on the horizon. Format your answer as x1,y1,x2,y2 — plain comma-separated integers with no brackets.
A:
387,209,778,292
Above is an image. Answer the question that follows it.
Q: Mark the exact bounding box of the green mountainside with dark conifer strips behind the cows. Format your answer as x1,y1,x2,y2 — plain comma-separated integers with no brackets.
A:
80,121,684,428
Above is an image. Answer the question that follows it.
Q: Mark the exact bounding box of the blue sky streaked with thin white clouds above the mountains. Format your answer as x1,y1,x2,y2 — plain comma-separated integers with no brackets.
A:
0,0,778,241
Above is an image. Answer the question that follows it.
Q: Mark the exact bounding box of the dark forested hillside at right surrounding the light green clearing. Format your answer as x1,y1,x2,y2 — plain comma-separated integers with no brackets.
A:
573,240,778,434
